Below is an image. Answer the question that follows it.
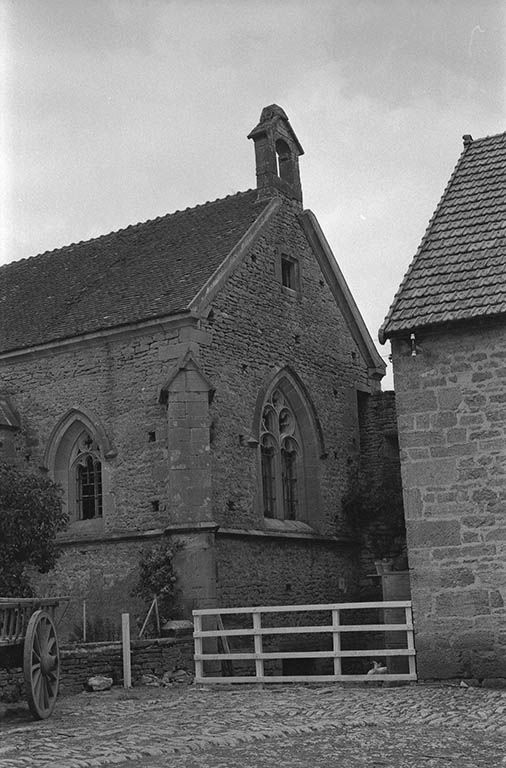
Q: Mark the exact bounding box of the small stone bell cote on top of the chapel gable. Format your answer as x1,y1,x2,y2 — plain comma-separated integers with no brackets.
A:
248,104,304,205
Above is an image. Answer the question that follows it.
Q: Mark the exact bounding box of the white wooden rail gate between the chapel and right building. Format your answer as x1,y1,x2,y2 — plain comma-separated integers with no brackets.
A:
193,600,417,684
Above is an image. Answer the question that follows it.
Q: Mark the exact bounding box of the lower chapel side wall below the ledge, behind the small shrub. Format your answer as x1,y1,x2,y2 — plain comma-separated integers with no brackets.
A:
37,528,216,642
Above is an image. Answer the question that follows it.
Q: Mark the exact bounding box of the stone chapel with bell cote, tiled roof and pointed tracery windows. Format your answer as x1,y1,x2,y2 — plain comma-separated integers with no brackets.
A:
0,105,392,636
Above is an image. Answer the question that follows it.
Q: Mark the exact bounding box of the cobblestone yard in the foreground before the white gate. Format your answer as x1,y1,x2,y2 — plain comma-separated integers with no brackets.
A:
0,685,506,768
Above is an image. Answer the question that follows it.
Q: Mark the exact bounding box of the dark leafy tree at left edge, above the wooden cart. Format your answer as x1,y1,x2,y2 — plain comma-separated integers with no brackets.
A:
0,463,68,597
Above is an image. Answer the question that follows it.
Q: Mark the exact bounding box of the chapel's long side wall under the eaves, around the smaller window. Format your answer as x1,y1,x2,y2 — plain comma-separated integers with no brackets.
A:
0,321,215,628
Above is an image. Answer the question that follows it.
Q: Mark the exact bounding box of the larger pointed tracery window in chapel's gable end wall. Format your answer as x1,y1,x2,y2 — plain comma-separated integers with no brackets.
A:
260,389,303,520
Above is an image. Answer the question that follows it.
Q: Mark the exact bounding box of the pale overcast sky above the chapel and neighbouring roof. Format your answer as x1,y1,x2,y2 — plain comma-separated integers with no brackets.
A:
0,0,506,386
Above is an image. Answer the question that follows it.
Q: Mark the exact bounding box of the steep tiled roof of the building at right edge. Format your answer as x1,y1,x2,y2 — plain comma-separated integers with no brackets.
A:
379,133,506,343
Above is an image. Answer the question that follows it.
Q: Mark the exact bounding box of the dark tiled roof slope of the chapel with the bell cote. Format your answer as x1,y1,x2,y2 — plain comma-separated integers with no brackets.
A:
0,190,268,352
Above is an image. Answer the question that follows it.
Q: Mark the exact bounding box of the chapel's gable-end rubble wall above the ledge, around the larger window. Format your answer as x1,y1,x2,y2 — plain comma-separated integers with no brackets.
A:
202,202,378,534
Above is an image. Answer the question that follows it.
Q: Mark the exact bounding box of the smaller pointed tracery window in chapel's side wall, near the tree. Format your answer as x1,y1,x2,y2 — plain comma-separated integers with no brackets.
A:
69,432,102,520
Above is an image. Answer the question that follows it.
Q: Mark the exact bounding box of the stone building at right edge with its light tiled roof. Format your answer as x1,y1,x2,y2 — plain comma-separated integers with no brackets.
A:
380,133,506,678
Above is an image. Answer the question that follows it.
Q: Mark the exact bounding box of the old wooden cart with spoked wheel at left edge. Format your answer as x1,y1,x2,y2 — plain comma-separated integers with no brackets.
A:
0,597,67,720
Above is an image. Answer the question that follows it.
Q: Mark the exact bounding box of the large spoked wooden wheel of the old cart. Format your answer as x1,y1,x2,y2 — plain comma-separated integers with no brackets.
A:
23,611,60,720
